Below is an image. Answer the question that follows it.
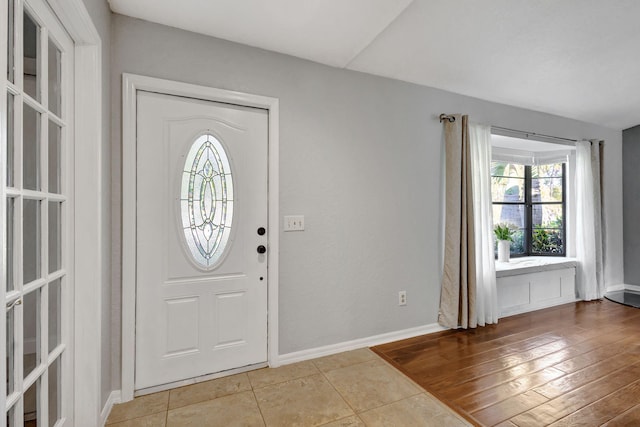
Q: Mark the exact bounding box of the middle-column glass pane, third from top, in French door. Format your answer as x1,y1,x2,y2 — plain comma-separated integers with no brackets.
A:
22,199,41,283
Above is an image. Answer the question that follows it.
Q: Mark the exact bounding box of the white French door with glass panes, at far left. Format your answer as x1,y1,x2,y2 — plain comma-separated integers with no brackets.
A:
0,0,73,427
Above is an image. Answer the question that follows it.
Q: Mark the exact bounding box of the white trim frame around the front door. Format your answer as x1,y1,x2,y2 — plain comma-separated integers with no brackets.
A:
122,73,280,402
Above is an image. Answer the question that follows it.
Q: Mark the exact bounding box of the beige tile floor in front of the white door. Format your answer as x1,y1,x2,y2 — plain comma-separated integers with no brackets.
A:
107,349,470,427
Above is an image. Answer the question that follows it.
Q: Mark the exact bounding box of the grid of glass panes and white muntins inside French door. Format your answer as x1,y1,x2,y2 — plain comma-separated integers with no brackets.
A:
2,0,66,426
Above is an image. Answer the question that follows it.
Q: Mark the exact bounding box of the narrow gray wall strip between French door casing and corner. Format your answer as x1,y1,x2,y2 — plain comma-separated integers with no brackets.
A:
83,0,111,412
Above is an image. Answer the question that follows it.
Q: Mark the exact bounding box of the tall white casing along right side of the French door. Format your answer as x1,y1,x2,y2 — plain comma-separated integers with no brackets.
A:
0,0,108,426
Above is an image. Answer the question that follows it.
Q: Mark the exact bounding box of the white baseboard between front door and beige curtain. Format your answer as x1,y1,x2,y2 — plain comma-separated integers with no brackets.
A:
270,323,447,368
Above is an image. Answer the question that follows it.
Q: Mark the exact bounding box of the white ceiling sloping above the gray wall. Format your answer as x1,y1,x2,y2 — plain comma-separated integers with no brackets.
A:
109,0,640,129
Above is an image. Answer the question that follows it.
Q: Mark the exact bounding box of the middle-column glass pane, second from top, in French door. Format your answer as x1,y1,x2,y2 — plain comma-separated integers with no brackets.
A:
22,104,40,190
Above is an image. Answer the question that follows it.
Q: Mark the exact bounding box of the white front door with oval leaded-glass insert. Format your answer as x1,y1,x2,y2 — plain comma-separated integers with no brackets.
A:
135,91,268,390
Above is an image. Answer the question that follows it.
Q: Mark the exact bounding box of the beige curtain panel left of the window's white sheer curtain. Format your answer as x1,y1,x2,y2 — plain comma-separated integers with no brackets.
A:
438,114,477,328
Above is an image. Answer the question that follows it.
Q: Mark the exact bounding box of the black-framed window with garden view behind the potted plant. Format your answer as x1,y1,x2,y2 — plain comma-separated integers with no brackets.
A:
491,161,566,256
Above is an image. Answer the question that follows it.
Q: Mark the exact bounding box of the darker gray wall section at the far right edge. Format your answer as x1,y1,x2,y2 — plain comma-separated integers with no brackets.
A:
622,126,640,285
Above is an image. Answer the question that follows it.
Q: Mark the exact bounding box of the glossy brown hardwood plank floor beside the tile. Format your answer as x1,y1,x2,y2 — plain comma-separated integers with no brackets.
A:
373,300,640,427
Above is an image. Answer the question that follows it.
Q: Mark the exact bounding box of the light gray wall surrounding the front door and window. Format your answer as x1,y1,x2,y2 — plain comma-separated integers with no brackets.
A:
111,15,622,388
